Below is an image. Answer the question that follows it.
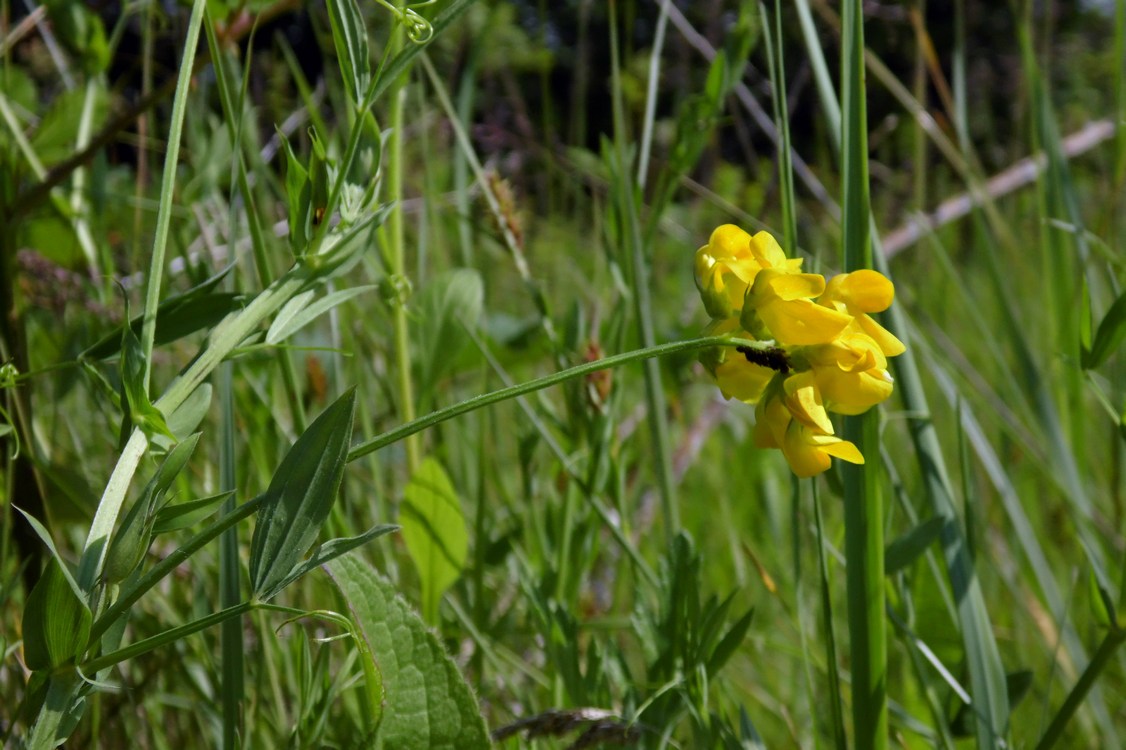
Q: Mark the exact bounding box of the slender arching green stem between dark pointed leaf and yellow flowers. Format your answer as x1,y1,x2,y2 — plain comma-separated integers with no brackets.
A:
348,336,770,463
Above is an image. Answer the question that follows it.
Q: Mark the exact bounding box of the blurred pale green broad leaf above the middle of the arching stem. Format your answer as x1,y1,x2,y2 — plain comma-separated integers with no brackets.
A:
415,268,484,401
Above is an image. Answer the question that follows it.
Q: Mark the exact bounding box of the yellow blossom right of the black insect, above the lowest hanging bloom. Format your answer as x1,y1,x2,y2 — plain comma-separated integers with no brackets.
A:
802,329,894,414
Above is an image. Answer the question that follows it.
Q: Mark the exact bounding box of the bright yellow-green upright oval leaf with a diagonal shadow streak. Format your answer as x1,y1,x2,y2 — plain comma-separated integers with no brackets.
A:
399,458,468,624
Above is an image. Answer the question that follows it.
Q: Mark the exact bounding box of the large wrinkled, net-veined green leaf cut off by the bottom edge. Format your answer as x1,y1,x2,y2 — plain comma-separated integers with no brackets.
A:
328,555,490,750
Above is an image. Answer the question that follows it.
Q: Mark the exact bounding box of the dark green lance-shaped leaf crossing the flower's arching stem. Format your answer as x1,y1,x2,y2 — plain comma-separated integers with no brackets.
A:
250,389,356,600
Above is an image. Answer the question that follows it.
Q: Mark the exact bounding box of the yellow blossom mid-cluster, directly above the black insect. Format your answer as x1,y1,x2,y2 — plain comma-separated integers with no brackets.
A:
740,268,852,346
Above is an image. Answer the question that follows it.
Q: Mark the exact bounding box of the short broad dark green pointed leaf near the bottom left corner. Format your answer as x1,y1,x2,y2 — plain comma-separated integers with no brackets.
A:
24,557,92,670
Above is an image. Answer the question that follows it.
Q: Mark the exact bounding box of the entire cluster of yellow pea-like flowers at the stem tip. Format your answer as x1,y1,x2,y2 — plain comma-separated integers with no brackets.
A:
696,224,904,476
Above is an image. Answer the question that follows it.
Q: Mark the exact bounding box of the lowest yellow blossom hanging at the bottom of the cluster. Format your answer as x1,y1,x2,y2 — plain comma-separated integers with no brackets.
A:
754,376,864,477
